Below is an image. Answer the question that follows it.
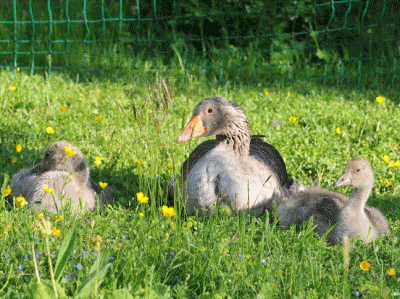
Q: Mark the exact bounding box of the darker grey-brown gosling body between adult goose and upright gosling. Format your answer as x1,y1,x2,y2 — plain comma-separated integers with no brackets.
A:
277,187,348,236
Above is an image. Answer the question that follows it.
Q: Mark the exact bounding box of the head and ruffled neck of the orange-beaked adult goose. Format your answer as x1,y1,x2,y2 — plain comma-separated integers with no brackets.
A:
178,96,250,155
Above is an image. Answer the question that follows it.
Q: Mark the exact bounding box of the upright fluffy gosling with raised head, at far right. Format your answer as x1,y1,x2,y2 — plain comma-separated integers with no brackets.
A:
327,158,390,244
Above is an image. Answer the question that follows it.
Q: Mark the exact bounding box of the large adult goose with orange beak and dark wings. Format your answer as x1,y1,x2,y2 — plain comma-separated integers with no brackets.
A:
173,96,295,215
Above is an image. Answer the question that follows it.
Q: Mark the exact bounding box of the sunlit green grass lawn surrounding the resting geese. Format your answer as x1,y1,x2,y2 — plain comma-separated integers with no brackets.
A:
0,71,400,298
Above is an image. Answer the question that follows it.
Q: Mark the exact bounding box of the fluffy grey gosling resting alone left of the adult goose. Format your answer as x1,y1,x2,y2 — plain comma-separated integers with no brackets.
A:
10,140,113,213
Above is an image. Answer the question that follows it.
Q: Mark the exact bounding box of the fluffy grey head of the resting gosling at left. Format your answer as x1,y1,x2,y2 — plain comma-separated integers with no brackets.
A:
42,140,89,184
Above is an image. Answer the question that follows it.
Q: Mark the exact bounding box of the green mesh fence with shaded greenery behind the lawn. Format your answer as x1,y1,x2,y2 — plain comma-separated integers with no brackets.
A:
0,0,400,88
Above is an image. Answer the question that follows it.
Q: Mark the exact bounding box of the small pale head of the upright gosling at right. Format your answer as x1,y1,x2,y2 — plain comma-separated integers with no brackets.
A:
333,157,374,189
